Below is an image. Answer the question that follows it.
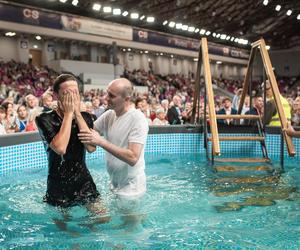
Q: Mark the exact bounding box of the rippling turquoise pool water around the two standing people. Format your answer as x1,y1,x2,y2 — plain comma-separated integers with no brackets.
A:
0,154,300,249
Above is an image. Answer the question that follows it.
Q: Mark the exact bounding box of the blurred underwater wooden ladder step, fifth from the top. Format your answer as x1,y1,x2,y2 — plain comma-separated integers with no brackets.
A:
214,176,279,184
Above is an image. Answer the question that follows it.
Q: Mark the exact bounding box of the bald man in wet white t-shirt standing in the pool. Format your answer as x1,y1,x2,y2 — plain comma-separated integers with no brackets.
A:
79,78,149,198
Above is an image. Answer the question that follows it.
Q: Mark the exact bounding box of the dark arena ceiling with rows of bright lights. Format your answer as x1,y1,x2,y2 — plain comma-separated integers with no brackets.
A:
5,0,300,49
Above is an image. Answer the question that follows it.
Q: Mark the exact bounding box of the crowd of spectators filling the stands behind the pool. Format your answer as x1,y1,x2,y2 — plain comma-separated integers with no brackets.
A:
0,60,300,134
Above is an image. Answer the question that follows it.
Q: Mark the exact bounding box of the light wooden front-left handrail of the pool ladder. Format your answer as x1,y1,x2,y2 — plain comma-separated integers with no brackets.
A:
201,37,220,155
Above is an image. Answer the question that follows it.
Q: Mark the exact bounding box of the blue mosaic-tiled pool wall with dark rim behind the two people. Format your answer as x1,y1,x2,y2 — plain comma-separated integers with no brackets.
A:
0,126,300,175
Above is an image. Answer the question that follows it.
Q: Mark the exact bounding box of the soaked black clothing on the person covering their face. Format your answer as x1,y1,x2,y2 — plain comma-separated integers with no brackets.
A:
36,111,99,207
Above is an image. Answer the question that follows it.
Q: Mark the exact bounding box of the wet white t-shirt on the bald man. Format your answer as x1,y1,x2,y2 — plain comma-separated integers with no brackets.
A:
94,108,149,197
